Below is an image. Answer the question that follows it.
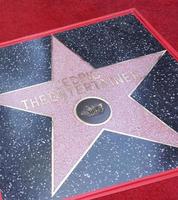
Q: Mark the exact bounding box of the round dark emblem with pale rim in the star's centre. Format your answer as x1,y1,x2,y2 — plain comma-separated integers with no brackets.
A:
75,97,111,125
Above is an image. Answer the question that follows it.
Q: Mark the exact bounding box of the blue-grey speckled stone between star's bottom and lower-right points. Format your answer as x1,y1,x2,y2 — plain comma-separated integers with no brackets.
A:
54,131,178,200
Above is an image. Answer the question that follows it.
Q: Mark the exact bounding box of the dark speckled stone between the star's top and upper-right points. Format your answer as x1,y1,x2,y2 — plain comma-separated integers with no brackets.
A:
55,15,163,68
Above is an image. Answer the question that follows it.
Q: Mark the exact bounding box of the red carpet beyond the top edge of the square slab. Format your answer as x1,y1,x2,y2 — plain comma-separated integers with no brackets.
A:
0,0,178,56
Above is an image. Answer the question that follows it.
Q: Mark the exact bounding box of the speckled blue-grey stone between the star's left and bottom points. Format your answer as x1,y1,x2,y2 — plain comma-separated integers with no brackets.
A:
0,106,52,200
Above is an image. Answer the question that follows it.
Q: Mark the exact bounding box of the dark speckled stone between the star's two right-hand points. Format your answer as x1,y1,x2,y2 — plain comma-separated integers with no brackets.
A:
132,53,178,132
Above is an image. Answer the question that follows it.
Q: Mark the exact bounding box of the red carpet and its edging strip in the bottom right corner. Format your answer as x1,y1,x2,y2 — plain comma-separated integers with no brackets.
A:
68,170,178,200
